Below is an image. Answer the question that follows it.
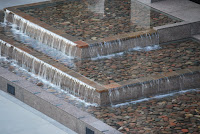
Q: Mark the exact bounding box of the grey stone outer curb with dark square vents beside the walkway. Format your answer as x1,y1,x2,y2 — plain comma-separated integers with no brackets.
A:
0,67,121,134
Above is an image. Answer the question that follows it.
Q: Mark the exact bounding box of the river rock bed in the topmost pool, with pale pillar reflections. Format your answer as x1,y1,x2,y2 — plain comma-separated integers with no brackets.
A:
19,0,180,41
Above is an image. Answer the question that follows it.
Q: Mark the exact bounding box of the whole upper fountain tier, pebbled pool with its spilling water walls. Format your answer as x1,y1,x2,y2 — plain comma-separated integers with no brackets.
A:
4,0,180,59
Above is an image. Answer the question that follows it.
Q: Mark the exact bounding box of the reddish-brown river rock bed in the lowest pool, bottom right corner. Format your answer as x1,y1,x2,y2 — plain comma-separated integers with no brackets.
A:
88,90,200,134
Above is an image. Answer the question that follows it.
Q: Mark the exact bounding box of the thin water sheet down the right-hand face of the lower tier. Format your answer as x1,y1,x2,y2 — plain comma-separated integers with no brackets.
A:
108,73,196,106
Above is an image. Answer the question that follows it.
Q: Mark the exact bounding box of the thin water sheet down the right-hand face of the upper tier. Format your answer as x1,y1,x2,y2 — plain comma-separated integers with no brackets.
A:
88,33,160,59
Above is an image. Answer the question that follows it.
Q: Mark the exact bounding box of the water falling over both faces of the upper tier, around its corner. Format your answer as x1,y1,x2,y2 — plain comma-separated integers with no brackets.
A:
4,10,159,58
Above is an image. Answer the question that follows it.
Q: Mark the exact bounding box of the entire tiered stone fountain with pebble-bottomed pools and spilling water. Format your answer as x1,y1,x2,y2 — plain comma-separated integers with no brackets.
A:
0,0,200,133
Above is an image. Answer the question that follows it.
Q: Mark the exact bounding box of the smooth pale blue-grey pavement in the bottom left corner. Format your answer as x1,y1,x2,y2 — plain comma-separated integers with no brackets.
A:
0,90,76,134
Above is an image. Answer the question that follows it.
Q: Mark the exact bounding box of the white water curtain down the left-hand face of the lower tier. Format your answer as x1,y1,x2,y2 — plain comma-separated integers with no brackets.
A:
0,40,97,101
